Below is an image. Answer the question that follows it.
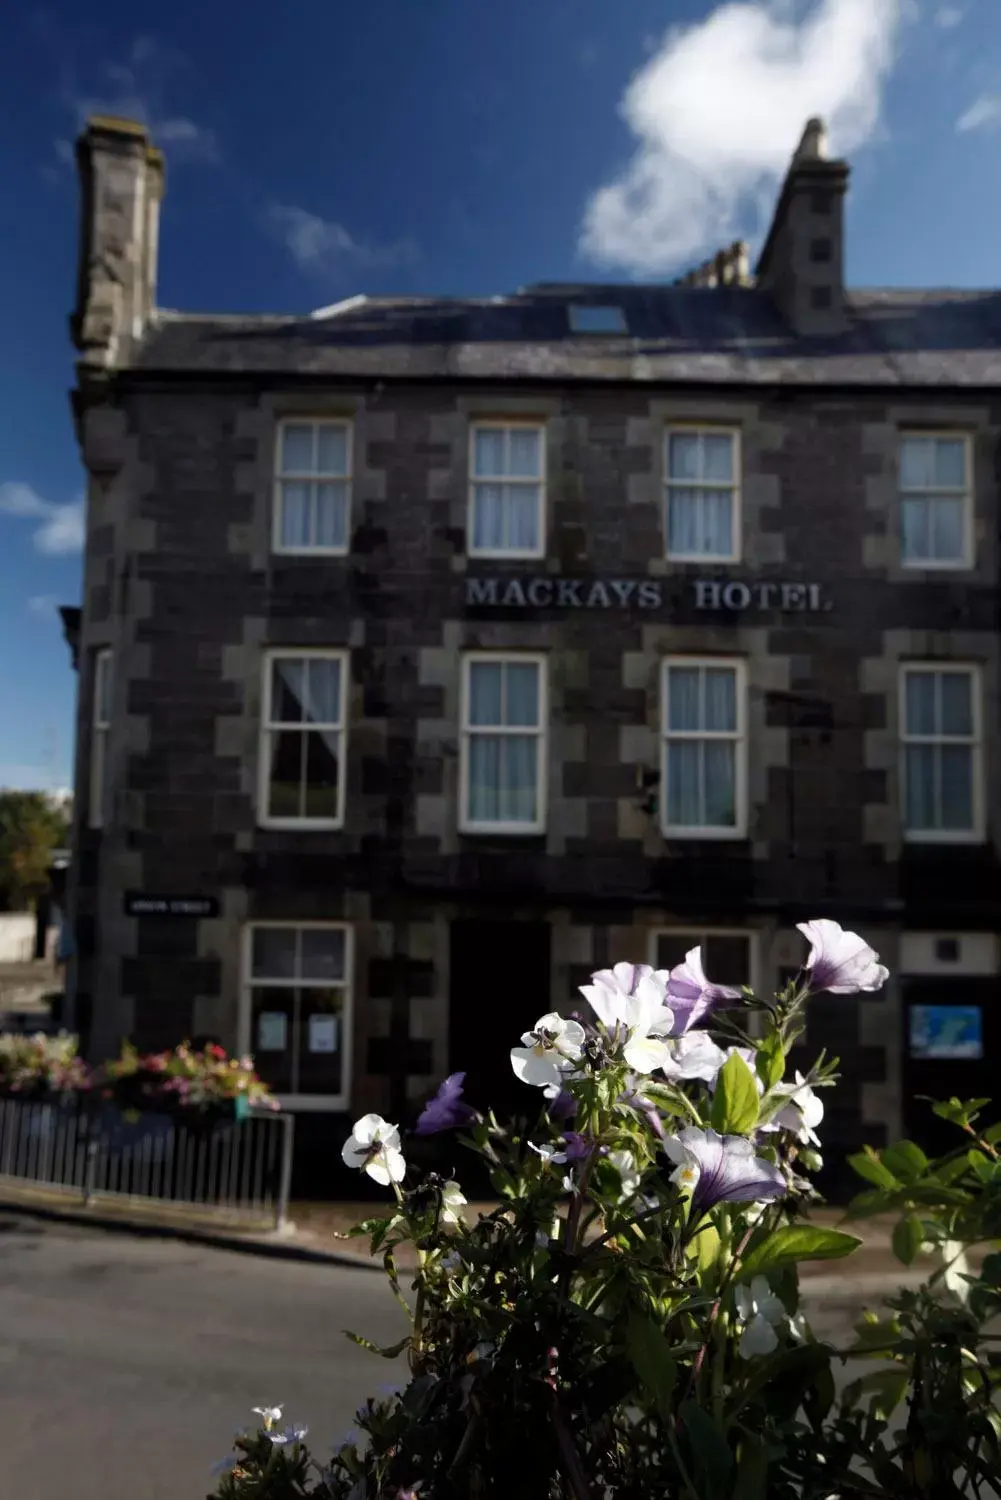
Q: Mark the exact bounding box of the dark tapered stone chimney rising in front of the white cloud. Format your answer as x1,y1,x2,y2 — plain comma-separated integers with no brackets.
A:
756,120,848,338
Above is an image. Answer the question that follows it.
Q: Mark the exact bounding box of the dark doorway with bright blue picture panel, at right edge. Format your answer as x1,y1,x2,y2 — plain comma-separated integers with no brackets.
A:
902,977,1001,1155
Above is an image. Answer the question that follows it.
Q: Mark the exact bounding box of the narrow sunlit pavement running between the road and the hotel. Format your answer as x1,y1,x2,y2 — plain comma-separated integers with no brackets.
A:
0,1184,932,1307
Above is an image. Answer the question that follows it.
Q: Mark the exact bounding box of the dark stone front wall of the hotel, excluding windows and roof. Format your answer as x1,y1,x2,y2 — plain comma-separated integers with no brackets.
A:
68,383,1001,1146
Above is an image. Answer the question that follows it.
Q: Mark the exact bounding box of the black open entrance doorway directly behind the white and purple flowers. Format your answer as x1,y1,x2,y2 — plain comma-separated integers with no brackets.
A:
449,921,552,1122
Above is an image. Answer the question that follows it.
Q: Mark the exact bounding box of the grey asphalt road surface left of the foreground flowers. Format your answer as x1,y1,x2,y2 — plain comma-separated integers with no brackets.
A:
0,1215,404,1500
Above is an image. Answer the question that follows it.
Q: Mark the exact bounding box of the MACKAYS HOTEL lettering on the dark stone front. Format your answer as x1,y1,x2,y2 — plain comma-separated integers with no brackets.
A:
465,573,833,614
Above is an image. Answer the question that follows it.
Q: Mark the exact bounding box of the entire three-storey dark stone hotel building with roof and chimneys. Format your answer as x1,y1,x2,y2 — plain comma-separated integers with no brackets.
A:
60,119,1001,1176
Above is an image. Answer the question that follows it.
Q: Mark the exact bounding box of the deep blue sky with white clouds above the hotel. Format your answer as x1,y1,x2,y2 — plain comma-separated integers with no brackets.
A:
0,0,1001,786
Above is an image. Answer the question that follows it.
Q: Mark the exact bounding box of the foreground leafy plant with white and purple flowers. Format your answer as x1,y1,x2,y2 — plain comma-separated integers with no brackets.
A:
207,921,1001,1500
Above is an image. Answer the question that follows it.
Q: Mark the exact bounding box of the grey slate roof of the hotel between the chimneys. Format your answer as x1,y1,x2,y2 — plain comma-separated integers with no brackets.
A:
134,284,1001,389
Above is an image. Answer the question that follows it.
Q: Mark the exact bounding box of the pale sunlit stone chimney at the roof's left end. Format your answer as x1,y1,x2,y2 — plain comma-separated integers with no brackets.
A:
71,116,164,371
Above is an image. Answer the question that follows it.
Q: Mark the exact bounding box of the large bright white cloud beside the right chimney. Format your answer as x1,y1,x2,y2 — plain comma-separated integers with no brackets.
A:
579,0,905,275
